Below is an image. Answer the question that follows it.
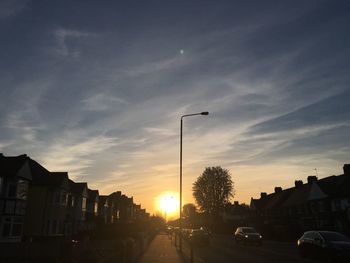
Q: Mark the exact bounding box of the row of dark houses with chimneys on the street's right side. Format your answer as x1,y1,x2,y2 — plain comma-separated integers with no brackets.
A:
250,164,350,237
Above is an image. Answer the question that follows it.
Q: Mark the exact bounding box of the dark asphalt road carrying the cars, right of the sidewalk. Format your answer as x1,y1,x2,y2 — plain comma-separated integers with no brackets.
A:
190,236,316,263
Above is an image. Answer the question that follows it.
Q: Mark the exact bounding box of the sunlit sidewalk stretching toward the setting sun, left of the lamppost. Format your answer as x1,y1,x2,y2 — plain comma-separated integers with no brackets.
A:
140,234,183,263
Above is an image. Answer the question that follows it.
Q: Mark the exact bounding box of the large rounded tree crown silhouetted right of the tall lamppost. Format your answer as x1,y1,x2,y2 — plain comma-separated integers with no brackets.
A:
192,166,235,215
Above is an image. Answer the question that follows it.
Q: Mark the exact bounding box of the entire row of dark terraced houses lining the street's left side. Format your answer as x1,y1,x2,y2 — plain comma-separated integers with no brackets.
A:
0,154,149,243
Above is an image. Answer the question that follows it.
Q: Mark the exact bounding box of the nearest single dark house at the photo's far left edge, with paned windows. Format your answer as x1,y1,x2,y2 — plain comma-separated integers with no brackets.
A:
0,154,32,242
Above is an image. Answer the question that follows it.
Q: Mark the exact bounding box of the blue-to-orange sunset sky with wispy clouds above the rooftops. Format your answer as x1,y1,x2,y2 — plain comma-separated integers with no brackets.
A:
0,0,350,213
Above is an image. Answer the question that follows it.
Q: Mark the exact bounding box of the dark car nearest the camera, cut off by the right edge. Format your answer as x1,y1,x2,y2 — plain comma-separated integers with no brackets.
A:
297,231,350,262
